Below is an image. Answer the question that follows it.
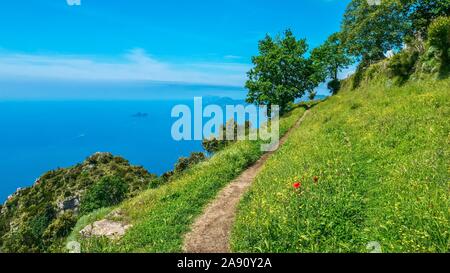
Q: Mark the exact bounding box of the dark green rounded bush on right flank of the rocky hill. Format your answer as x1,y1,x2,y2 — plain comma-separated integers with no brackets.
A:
80,176,128,214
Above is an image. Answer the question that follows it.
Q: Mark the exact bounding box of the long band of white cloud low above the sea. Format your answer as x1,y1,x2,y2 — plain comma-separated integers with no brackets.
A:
0,49,250,86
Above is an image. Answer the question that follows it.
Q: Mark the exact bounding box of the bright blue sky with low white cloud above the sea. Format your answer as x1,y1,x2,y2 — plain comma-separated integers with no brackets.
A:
0,0,349,88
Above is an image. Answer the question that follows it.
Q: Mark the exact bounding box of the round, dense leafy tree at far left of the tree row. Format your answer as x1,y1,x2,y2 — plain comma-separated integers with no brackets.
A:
245,30,315,113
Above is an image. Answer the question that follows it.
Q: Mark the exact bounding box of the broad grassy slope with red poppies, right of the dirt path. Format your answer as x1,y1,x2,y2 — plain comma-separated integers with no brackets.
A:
232,76,450,252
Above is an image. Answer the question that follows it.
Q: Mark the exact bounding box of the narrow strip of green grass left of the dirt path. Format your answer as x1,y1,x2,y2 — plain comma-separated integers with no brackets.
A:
74,105,304,252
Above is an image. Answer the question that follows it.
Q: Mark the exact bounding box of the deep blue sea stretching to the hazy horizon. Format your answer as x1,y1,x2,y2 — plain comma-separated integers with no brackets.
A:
0,79,245,202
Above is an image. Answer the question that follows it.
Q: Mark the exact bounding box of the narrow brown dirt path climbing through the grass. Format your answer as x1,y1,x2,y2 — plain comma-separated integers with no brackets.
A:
183,110,309,253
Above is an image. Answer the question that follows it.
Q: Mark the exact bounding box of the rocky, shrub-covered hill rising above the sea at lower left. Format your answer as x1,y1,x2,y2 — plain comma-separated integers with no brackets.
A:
0,153,156,252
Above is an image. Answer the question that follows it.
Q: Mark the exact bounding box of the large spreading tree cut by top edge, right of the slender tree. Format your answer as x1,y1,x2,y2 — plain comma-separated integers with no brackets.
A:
342,0,408,65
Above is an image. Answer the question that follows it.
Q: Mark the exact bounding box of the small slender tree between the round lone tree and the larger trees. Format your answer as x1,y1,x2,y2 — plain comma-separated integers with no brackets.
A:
311,33,352,94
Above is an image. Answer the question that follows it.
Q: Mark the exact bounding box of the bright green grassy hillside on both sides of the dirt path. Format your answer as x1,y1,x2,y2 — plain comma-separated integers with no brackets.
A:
68,68,450,252
